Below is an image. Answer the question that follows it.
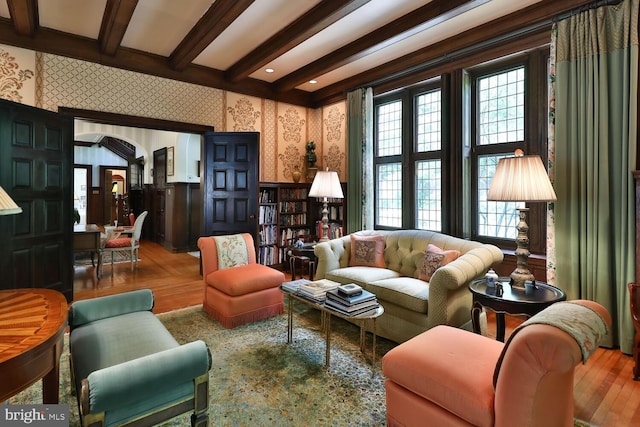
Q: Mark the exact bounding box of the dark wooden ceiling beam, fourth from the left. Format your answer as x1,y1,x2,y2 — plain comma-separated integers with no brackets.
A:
225,0,370,82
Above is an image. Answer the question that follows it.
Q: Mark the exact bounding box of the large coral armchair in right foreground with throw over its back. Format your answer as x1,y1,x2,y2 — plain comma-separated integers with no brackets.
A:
382,300,611,427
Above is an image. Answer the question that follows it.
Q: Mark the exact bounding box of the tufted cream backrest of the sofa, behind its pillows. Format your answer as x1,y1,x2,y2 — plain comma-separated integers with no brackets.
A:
340,230,483,278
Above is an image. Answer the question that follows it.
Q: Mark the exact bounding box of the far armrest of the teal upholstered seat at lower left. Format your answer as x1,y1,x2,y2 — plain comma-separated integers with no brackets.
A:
69,289,154,330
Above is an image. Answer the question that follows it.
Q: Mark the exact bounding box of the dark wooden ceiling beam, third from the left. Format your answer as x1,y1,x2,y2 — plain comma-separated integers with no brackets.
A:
169,0,254,70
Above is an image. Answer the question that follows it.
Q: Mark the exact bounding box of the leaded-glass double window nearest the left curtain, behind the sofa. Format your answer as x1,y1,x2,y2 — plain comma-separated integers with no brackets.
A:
374,85,443,231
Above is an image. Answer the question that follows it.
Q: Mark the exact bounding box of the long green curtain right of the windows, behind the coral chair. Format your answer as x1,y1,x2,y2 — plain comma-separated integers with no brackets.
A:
549,0,638,353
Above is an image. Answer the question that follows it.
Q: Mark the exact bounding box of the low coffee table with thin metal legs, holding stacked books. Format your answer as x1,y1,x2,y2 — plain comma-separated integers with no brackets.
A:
280,287,384,369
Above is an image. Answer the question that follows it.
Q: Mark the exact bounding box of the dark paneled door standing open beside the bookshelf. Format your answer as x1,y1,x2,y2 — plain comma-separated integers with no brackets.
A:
200,132,260,242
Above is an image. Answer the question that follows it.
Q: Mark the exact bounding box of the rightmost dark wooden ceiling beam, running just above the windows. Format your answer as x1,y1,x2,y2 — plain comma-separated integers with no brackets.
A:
312,0,592,106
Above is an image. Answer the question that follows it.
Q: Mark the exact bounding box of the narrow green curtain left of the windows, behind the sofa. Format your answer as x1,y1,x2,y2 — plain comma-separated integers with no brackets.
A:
347,88,374,233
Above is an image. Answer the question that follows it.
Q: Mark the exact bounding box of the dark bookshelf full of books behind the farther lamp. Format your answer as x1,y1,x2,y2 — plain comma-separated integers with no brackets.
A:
258,182,346,266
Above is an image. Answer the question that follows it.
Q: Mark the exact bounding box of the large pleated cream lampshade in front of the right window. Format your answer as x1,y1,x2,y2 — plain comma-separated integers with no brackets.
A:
487,156,556,202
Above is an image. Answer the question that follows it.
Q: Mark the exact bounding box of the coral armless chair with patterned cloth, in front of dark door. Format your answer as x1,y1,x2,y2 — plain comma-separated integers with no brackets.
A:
198,233,284,328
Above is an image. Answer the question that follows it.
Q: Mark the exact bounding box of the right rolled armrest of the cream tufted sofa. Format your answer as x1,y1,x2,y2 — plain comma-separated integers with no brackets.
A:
428,244,504,328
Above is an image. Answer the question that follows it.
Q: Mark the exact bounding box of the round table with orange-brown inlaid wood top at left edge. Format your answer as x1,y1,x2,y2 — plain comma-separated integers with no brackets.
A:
0,289,67,403
